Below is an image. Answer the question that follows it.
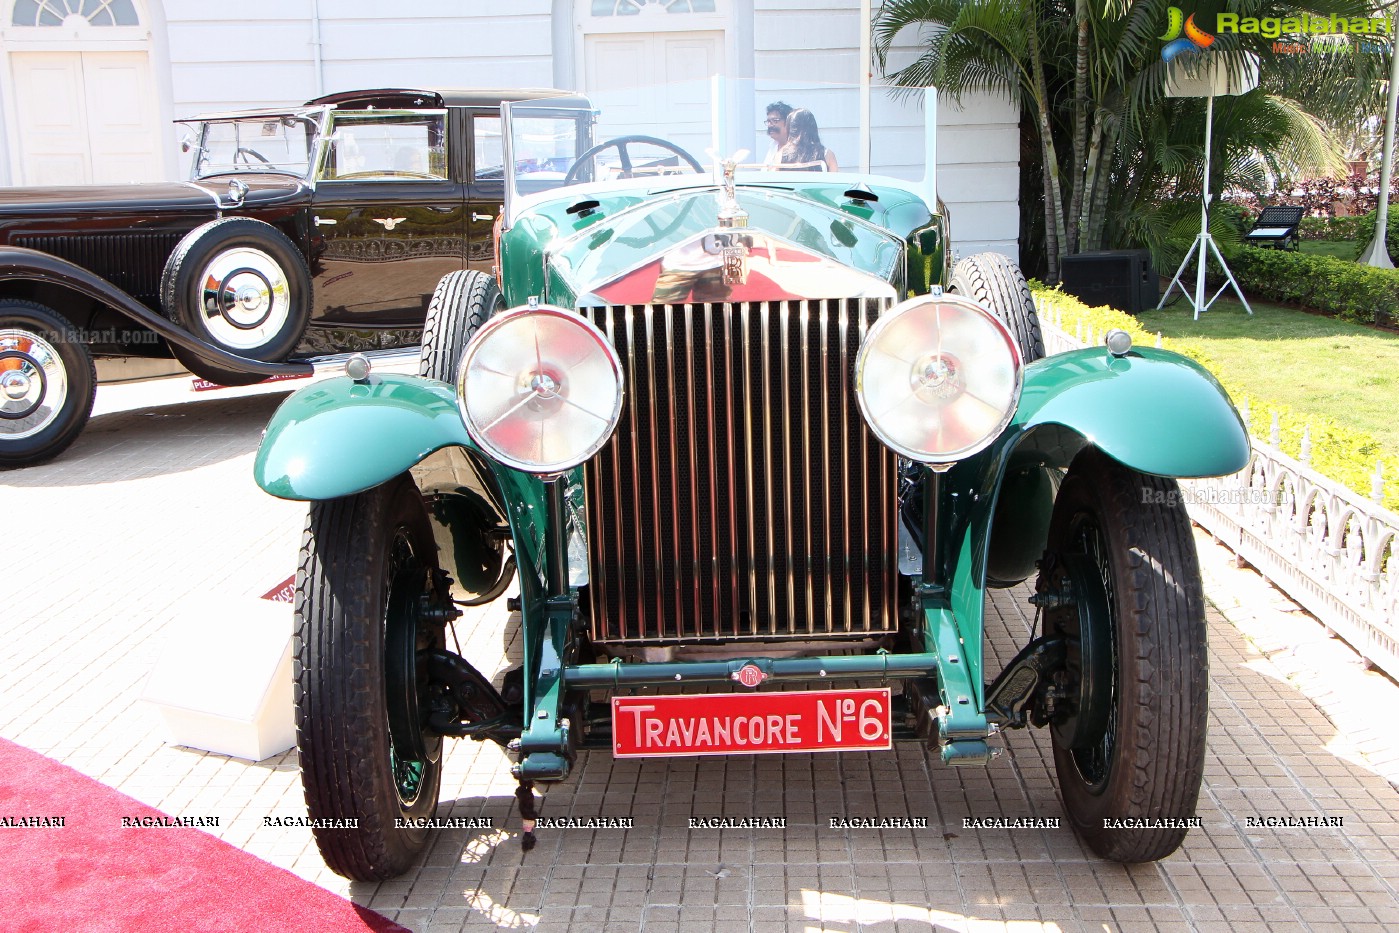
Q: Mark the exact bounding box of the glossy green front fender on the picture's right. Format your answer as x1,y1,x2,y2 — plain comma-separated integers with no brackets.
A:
1007,348,1249,477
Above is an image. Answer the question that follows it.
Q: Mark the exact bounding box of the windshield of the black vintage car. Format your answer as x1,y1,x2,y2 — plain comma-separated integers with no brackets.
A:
192,111,325,179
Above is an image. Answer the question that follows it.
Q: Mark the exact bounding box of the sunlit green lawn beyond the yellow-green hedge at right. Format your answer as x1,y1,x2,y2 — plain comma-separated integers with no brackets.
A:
1137,298,1399,456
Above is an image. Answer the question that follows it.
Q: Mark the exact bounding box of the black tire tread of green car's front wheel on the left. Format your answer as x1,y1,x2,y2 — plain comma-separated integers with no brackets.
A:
295,477,439,881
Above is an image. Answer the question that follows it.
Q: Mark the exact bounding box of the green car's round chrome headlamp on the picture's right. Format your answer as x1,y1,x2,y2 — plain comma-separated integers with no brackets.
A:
855,295,1021,463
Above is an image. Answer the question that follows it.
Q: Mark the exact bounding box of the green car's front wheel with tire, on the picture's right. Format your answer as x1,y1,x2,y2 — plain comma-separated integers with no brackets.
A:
1037,448,1209,862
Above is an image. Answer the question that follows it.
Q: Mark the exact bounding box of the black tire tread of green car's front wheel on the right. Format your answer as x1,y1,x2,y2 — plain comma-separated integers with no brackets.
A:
1051,448,1209,862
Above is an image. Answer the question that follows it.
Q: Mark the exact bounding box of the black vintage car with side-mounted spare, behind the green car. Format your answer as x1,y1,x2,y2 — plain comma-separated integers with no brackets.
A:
0,90,592,466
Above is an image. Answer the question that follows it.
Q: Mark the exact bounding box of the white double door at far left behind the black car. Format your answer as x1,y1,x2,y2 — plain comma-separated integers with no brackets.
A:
10,52,164,185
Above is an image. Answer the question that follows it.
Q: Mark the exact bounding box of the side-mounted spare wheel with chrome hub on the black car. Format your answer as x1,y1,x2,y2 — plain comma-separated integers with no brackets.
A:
161,217,311,386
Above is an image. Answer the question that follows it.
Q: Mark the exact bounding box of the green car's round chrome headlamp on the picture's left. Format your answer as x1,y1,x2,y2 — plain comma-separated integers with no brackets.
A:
456,305,623,474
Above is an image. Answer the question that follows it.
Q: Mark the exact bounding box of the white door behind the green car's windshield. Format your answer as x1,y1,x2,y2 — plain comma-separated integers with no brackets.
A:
583,31,723,161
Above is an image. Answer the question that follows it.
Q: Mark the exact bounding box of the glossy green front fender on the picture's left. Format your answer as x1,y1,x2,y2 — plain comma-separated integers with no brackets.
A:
253,375,476,499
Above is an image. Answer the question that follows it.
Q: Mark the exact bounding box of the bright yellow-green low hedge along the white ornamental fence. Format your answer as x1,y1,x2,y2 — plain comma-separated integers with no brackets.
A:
1030,282,1399,512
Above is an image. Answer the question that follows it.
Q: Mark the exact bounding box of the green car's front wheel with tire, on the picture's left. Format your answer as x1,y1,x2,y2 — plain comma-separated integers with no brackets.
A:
297,474,445,881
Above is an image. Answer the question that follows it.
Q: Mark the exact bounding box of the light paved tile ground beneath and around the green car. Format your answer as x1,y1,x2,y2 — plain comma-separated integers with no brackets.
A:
0,382,1399,933
